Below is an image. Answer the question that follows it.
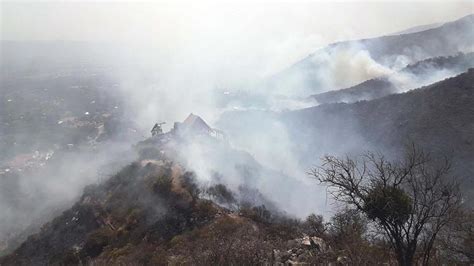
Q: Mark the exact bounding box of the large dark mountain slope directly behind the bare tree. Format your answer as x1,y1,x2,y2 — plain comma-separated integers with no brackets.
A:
281,69,474,201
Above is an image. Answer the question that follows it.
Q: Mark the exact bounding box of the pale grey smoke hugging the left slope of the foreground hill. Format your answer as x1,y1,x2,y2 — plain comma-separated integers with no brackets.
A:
0,141,134,249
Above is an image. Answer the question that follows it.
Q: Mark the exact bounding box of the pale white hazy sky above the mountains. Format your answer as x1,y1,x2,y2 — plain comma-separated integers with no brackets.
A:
0,0,474,75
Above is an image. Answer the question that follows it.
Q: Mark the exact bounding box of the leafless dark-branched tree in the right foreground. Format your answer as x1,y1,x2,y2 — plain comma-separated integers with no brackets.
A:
310,145,461,266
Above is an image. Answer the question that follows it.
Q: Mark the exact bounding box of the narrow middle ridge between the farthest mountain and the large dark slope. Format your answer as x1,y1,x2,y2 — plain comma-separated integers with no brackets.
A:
311,53,474,104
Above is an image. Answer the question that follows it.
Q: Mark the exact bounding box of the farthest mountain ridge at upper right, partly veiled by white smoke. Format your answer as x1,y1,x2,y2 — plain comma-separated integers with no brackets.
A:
266,15,474,96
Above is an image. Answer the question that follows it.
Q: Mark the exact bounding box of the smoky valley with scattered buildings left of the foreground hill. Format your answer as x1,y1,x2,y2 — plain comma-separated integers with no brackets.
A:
0,59,140,250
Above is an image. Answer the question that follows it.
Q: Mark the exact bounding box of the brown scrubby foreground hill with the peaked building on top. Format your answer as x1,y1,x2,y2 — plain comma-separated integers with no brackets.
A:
0,136,370,265
